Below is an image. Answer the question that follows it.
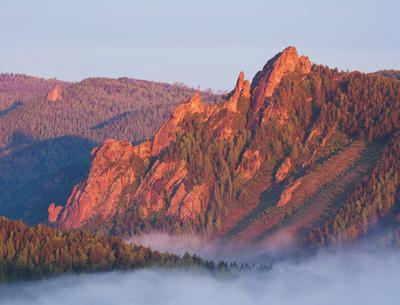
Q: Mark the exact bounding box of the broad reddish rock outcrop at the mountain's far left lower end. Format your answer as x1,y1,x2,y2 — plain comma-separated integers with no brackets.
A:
49,140,141,229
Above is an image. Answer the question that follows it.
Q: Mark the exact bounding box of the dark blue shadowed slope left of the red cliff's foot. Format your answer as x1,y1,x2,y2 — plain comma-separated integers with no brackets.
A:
0,133,95,224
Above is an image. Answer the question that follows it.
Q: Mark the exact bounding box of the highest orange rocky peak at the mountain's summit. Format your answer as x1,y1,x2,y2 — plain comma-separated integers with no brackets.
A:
251,46,311,113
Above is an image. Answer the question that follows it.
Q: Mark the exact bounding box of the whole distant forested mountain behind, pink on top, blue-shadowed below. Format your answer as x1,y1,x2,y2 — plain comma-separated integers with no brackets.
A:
0,74,220,224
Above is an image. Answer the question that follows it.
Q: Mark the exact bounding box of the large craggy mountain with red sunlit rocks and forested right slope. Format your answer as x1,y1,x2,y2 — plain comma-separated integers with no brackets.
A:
48,47,400,248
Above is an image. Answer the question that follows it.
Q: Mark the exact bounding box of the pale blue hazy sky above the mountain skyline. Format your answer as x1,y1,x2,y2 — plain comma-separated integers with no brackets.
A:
0,0,400,90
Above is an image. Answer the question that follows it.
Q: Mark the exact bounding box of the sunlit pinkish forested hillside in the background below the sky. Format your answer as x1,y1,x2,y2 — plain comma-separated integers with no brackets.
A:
0,74,217,149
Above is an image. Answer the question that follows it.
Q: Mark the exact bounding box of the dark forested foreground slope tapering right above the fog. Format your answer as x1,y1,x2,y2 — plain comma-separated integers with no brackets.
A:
0,217,252,283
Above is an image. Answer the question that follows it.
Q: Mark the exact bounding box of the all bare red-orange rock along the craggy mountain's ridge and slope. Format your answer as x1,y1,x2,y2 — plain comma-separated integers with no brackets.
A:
49,47,322,235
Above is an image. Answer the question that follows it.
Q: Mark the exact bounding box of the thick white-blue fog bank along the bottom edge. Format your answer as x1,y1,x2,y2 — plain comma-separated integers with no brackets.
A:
0,251,400,305
